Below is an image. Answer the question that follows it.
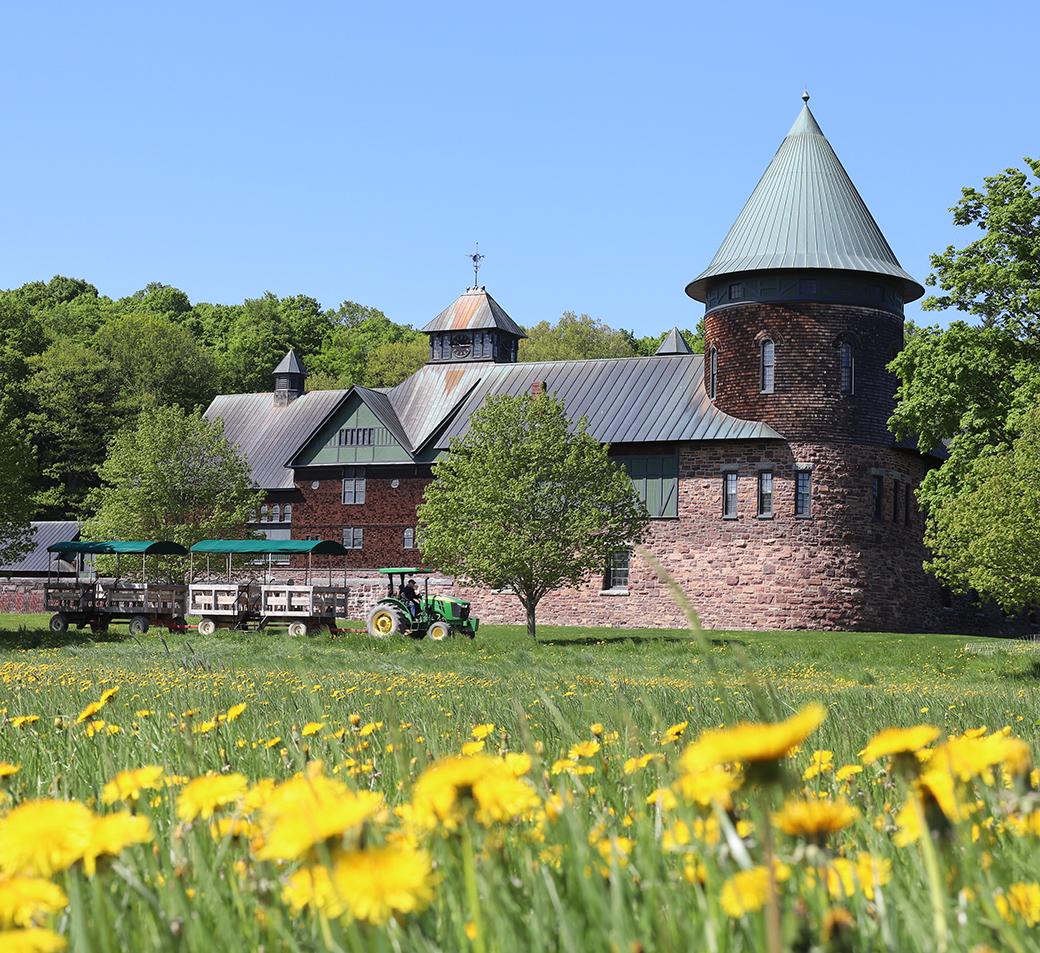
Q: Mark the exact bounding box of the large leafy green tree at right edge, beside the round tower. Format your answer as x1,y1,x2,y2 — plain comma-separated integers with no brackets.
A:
891,153,1040,609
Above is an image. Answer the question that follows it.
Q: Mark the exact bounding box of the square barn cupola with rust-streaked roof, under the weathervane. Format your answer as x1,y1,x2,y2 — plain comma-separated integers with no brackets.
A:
422,286,527,364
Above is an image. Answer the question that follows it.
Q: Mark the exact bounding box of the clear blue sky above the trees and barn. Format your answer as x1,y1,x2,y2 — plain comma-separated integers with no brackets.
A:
0,0,1040,333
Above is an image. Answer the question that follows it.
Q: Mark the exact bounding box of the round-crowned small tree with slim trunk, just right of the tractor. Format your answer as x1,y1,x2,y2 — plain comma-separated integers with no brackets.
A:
419,394,649,638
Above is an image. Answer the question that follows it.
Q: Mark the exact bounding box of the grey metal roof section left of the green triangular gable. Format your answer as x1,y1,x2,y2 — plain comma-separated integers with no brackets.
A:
206,390,347,490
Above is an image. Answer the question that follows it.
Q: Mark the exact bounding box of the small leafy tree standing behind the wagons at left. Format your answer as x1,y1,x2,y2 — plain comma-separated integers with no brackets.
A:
84,406,263,546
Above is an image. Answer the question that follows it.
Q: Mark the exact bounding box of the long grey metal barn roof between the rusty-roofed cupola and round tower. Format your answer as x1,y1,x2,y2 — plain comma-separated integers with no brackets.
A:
436,354,782,449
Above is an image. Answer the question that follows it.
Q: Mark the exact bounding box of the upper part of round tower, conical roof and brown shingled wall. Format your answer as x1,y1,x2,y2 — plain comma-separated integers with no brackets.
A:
686,94,925,444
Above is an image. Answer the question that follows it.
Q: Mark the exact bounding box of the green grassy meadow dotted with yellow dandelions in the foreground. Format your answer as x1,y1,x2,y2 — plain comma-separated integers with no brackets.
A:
0,616,1040,953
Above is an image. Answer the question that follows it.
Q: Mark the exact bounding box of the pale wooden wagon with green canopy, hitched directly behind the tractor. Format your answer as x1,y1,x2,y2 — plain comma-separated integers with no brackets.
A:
187,539,349,636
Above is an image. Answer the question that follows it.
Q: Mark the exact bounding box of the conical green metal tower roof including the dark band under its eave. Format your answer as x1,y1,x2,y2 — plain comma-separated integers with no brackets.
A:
686,93,925,314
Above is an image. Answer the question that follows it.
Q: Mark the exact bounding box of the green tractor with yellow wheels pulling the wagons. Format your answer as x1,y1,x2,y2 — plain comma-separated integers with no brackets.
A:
366,567,480,642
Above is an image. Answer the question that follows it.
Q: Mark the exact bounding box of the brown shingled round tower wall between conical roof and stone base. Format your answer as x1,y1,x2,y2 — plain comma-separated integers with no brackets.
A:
704,304,903,443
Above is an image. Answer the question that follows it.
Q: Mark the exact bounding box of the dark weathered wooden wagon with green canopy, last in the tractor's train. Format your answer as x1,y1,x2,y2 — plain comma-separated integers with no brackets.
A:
44,540,187,635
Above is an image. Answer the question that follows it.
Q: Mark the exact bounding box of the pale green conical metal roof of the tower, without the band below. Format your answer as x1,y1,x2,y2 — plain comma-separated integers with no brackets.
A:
686,94,925,301
